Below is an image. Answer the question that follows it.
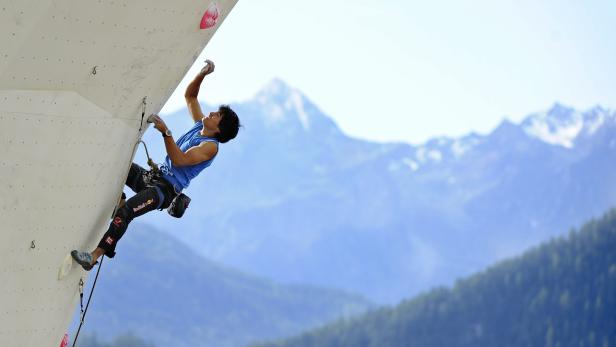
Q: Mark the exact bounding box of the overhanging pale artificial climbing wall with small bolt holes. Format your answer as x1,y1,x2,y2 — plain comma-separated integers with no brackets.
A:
0,0,237,347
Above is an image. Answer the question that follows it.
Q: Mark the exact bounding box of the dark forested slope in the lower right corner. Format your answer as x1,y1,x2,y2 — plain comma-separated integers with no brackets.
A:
253,210,616,347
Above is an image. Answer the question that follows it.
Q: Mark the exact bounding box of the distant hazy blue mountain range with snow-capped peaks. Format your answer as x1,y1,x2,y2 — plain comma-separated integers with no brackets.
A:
136,80,616,303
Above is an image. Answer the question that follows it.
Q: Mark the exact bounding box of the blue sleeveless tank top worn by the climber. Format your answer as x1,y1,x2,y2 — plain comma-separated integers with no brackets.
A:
160,121,218,192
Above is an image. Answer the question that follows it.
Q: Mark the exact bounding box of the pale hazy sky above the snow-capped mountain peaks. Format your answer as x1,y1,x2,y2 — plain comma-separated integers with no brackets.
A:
163,0,616,143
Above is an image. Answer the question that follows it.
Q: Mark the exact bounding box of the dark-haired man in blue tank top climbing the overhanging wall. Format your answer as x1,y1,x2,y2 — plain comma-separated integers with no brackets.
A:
71,60,240,271
